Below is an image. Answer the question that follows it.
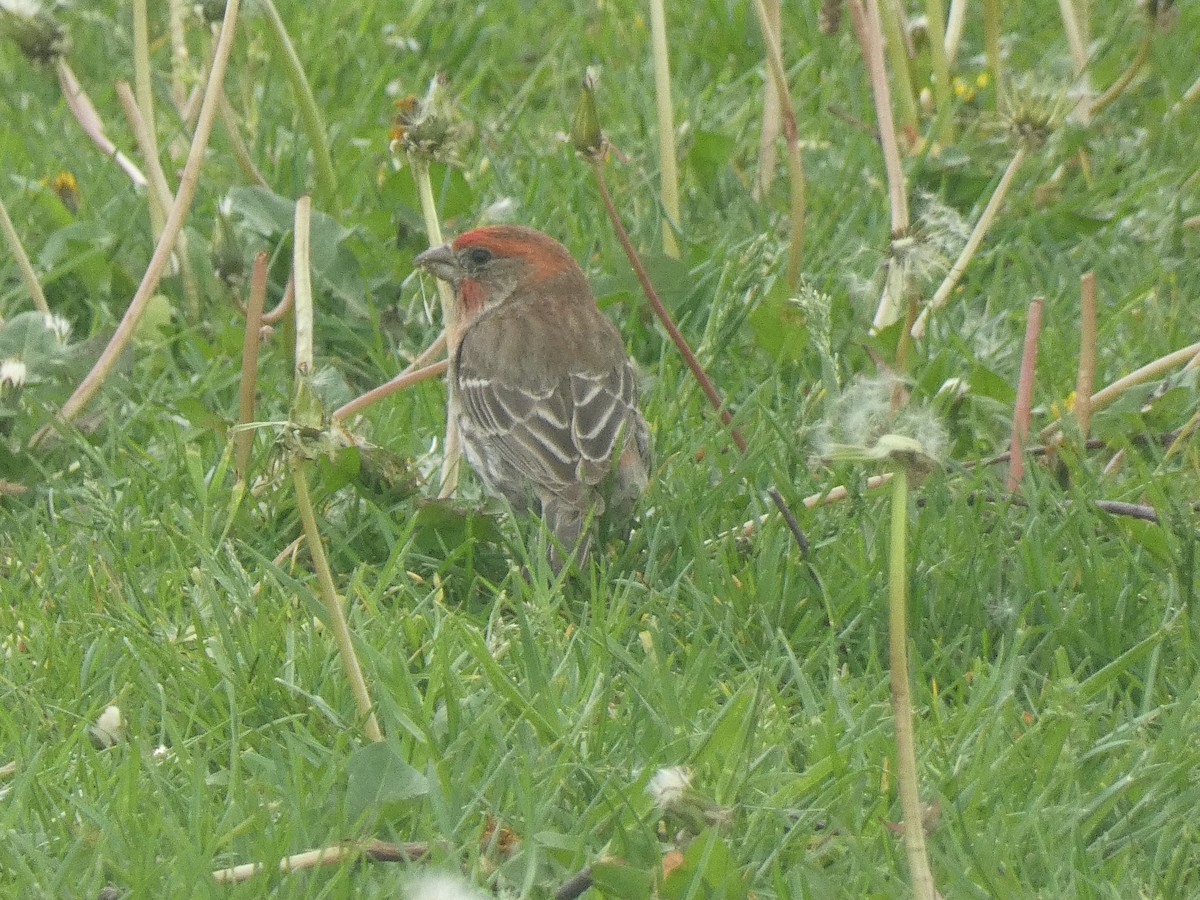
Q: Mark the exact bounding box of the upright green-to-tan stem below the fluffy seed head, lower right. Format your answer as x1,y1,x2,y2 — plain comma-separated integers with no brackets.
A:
888,466,937,900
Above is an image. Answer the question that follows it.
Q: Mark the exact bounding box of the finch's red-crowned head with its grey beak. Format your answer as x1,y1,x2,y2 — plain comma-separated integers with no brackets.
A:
413,226,587,324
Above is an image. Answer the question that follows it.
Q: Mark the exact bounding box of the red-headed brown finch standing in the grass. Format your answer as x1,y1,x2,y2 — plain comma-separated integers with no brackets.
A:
415,226,650,572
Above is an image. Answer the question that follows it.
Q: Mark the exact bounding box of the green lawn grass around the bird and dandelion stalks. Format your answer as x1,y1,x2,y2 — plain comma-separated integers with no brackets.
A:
0,0,1200,898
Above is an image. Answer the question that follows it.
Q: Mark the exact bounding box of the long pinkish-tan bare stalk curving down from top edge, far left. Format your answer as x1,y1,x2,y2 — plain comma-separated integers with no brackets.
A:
38,0,241,446
